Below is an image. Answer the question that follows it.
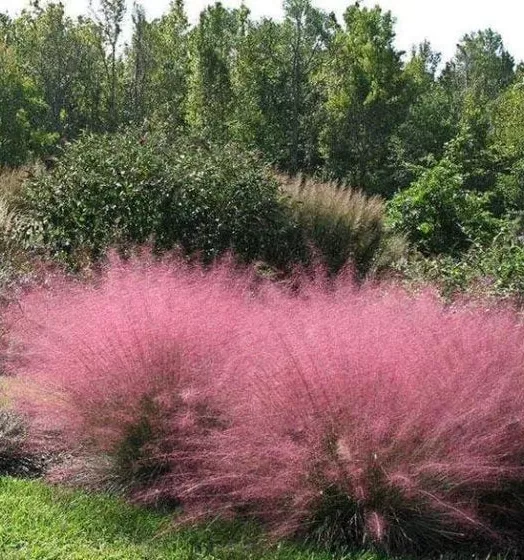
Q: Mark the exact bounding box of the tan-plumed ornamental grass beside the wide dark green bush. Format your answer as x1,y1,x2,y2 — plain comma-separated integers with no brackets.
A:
279,176,405,276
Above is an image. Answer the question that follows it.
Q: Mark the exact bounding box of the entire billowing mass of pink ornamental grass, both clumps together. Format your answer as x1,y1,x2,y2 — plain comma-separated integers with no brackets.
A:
9,256,524,551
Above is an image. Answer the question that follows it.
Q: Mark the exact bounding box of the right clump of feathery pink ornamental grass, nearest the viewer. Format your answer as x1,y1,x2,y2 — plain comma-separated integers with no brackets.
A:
179,284,524,549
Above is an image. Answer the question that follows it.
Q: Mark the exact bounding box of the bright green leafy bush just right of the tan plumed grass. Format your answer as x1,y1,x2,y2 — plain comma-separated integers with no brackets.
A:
388,159,498,254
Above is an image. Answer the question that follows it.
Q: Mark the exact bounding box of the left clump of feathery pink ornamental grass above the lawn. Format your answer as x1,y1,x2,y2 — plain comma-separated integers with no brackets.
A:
8,254,249,501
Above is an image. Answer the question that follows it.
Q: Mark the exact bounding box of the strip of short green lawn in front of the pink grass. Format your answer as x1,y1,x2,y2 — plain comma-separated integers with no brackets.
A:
0,478,379,560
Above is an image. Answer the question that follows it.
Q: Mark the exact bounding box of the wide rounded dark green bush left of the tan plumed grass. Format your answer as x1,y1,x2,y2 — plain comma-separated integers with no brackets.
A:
27,132,302,270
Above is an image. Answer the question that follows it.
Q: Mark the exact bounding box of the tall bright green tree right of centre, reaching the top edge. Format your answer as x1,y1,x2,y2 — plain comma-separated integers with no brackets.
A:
321,2,405,193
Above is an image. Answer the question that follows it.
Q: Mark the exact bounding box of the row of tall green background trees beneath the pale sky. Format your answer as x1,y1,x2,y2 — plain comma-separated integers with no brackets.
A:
0,0,522,221
